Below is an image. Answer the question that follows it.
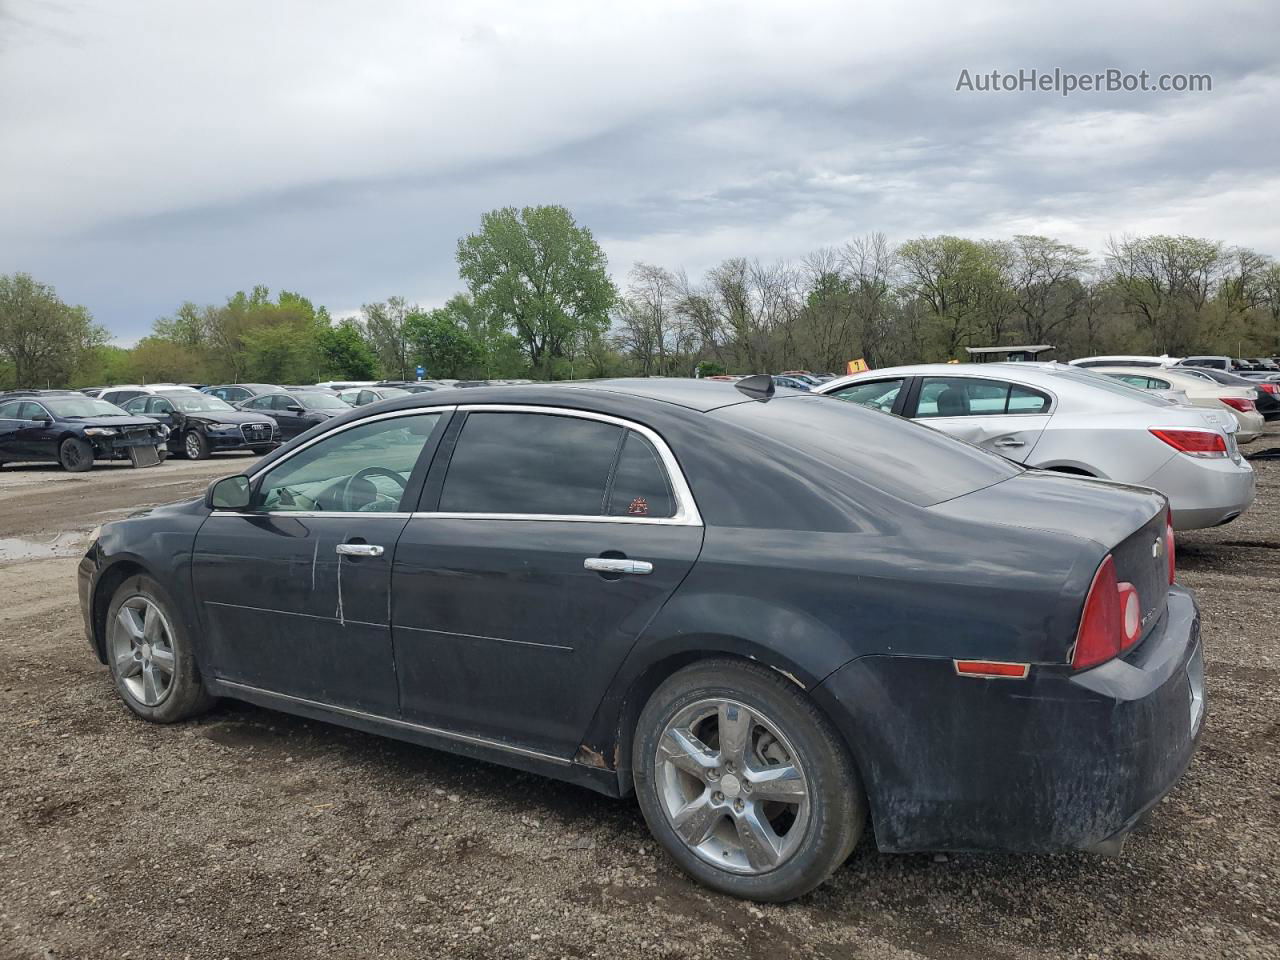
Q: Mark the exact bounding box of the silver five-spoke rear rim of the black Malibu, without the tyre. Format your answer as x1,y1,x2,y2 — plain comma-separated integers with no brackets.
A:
654,699,809,874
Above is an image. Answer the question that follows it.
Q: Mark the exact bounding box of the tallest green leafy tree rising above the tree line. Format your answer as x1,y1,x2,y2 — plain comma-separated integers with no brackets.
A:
457,206,617,379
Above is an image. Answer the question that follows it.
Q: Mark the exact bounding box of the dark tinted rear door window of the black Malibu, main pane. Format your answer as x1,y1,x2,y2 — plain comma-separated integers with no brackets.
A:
440,412,622,517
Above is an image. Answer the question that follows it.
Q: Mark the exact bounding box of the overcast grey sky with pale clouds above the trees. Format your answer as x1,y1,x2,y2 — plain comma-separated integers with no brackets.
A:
0,0,1280,343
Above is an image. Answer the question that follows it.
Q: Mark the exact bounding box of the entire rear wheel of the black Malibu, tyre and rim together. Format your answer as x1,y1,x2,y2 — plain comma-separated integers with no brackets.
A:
632,659,867,902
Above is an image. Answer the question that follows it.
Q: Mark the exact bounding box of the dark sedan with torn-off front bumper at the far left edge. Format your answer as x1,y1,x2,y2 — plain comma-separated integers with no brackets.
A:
0,390,169,474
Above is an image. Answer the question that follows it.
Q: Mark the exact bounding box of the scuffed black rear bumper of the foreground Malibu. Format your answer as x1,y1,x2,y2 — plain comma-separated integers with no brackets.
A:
817,588,1204,852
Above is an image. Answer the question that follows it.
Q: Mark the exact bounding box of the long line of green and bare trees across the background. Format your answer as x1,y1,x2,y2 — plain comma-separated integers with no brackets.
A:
0,212,1280,387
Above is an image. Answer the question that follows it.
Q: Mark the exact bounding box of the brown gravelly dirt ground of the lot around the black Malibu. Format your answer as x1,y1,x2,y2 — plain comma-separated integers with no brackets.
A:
0,453,1280,960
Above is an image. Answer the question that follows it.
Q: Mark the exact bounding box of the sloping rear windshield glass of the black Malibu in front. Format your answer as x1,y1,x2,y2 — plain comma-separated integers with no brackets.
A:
710,397,1021,507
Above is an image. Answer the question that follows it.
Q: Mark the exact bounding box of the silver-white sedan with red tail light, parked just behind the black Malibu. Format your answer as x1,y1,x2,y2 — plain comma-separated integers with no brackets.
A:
814,364,1254,530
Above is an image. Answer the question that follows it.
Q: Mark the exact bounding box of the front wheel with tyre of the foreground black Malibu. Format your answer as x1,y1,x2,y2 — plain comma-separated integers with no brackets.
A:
105,575,215,723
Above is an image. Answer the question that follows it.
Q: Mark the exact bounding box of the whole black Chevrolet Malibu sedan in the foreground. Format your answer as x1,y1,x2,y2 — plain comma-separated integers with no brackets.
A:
79,378,1203,900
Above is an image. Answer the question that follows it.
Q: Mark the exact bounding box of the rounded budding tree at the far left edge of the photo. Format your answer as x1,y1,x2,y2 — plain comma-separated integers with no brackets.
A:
0,274,108,387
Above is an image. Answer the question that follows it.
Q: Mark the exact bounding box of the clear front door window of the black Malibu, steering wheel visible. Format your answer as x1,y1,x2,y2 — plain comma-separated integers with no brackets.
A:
253,412,440,513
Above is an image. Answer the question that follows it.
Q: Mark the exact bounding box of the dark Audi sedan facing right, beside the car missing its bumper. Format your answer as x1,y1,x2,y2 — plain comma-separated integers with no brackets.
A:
124,389,280,460
